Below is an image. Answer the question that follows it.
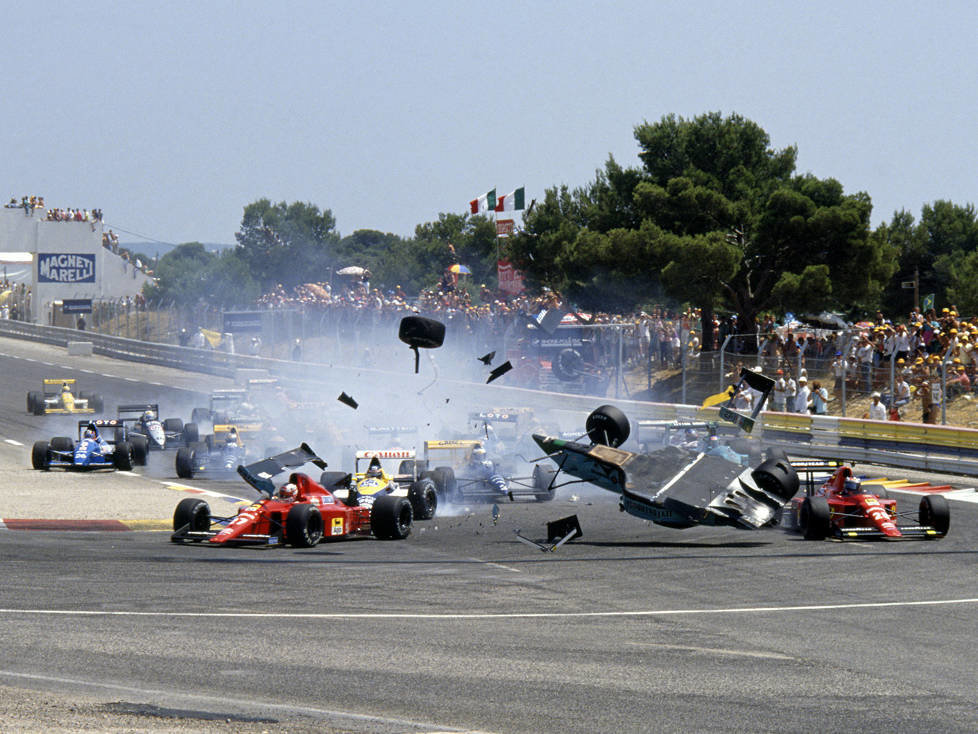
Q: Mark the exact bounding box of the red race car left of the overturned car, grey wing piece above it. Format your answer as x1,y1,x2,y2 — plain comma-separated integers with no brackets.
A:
170,444,414,548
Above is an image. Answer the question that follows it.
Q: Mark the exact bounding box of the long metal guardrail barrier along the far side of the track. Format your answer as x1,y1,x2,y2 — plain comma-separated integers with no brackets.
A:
0,319,978,476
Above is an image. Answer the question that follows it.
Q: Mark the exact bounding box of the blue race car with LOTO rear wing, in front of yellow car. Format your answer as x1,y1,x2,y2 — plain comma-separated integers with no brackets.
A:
31,420,139,471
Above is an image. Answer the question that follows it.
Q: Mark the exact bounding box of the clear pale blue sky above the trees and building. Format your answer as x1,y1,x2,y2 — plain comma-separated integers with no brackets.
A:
0,0,978,250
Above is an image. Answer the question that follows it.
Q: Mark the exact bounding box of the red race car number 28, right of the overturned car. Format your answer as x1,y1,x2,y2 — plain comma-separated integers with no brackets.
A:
785,461,951,540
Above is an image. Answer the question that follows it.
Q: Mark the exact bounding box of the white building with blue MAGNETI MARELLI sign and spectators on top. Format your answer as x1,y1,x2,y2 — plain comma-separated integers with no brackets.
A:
0,204,151,324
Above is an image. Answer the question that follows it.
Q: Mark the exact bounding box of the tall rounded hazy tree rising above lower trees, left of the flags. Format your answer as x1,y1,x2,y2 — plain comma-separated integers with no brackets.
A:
234,199,339,291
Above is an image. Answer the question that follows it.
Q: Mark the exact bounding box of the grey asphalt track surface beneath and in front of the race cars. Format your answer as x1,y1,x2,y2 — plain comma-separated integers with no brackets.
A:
0,342,978,732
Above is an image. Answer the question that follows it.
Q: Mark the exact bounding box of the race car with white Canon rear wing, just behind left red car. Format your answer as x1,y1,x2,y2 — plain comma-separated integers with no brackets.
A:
319,449,438,520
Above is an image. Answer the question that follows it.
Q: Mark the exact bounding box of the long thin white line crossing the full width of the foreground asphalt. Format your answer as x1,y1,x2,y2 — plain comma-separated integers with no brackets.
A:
0,598,978,620
